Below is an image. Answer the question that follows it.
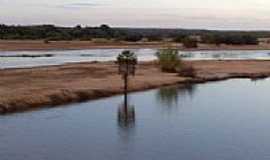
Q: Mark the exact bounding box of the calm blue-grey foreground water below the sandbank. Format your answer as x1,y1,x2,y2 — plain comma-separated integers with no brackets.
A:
0,79,270,160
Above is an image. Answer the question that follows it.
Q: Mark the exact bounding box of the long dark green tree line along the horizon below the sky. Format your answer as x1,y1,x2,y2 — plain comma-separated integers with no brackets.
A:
0,24,270,46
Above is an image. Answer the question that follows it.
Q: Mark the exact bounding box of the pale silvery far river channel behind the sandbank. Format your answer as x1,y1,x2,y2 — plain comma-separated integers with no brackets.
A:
0,49,270,68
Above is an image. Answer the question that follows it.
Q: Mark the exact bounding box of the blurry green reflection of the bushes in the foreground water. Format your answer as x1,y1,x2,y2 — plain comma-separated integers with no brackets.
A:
156,84,196,109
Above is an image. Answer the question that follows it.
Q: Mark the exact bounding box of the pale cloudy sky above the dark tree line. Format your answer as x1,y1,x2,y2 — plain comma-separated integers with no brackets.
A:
0,0,270,30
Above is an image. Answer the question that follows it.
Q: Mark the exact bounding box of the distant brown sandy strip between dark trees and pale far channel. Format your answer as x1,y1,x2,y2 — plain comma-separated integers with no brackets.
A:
0,40,270,51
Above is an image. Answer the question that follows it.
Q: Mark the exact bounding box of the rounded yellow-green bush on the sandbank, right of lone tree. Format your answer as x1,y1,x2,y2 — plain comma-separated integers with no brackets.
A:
156,49,181,72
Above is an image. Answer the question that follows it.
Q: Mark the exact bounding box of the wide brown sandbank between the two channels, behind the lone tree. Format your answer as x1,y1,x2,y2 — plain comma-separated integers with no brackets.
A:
0,61,270,113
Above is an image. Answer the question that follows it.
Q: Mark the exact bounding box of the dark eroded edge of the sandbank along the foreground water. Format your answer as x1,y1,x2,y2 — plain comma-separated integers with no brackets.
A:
0,70,270,115
